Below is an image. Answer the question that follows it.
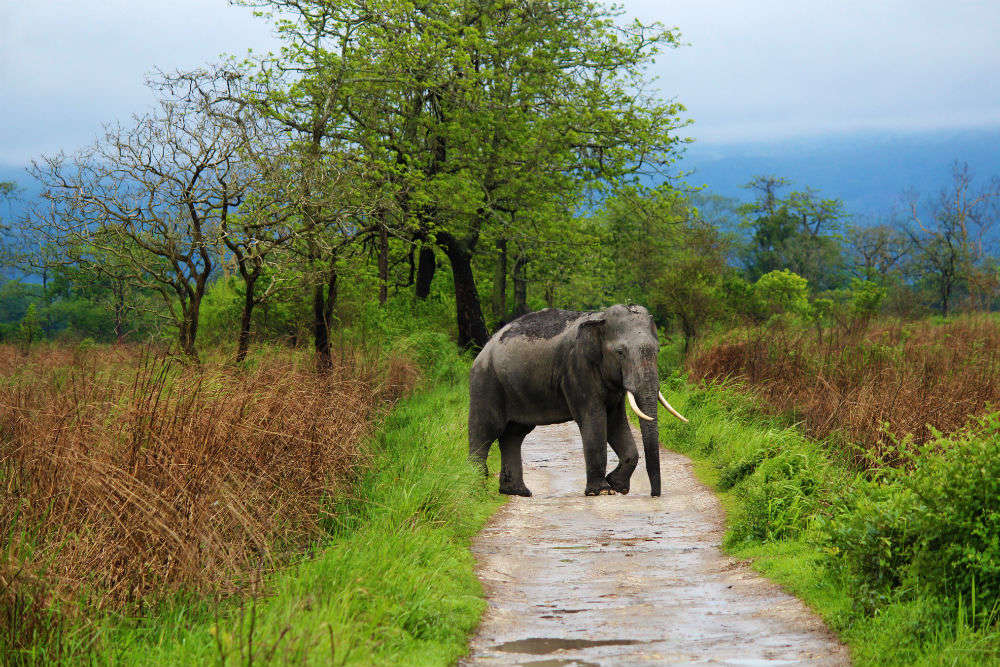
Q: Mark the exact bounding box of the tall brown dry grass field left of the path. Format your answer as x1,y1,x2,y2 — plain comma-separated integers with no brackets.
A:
0,346,416,648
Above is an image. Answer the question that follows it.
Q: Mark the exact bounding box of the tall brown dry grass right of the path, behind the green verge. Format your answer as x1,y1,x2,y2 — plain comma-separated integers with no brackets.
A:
687,315,1000,465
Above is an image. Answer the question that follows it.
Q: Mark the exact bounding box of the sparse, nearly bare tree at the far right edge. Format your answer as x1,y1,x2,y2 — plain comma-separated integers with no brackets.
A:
907,162,1000,315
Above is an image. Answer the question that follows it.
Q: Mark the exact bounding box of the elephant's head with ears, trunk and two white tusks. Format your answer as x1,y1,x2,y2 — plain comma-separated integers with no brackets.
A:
580,305,687,496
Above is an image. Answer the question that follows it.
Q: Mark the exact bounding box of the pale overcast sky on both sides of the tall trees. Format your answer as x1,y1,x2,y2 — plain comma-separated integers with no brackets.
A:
0,0,1000,164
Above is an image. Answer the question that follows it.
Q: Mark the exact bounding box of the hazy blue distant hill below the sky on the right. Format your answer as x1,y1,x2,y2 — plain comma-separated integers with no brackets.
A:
680,126,1000,215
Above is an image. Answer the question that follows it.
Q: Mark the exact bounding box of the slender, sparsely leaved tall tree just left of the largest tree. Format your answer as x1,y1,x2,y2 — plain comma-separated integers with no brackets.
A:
227,6,383,372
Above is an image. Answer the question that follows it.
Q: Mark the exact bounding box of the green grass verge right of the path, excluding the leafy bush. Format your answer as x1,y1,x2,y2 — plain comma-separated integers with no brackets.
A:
661,377,1000,665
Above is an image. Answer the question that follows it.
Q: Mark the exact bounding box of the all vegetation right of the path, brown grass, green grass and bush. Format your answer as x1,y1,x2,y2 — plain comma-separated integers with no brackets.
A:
663,315,1000,665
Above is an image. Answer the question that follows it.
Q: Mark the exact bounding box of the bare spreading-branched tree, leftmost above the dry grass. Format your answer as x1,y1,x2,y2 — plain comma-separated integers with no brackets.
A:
26,90,249,361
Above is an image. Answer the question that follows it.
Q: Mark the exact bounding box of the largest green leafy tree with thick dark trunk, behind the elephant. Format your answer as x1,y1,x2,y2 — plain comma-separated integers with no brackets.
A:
246,0,682,346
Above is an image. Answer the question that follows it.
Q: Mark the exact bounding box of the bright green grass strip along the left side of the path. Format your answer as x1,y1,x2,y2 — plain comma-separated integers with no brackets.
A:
61,363,502,665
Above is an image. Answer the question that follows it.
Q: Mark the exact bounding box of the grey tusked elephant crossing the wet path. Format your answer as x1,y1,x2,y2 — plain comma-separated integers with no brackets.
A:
469,305,687,496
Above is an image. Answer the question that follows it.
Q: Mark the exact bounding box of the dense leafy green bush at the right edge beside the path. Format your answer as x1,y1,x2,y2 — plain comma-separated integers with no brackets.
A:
825,414,1000,615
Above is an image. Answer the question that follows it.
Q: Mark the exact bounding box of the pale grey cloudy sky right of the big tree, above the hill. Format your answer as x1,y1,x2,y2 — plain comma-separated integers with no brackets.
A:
626,0,1000,142
